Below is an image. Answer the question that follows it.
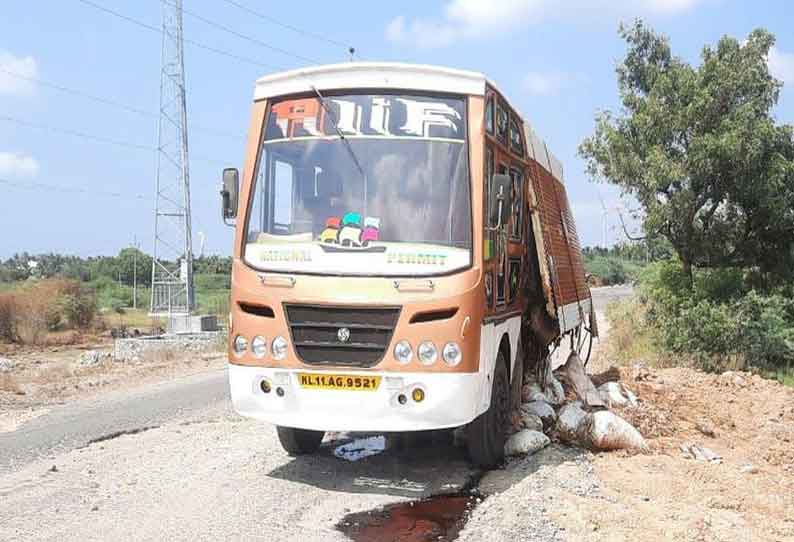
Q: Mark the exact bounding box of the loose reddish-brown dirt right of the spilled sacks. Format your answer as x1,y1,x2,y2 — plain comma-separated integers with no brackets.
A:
540,360,794,541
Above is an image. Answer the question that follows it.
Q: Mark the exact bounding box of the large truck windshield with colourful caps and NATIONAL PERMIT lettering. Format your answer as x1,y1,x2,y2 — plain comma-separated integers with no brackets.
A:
244,94,472,276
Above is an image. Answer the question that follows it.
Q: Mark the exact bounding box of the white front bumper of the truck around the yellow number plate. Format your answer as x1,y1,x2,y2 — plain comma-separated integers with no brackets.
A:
229,364,487,432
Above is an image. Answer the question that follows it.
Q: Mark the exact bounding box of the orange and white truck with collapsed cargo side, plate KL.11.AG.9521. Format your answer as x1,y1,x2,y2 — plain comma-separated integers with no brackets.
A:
221,62,595,466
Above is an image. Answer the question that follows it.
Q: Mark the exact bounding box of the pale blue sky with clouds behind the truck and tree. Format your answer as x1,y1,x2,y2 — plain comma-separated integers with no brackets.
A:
0,0,794,257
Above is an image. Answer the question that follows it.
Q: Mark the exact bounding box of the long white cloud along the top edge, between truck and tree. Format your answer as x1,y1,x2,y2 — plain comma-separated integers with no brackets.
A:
386,0,712,48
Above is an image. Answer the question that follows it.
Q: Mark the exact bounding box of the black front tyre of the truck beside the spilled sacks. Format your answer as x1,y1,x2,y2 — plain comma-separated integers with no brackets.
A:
466,351,510,468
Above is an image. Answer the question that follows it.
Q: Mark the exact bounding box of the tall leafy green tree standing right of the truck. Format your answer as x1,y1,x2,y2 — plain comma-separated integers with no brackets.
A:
579,20,794,282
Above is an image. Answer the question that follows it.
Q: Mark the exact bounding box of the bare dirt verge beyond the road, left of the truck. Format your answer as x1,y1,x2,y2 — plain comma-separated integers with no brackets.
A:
0,336,226,433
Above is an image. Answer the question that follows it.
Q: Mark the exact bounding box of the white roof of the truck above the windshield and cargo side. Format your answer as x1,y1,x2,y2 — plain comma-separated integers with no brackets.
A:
254,62,563,180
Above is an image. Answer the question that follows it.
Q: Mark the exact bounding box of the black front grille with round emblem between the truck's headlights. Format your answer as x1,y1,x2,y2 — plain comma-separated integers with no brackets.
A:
284,304,400,367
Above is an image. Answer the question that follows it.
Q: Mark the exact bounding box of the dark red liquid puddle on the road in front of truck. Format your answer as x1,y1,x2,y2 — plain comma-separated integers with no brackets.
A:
337,492,482,542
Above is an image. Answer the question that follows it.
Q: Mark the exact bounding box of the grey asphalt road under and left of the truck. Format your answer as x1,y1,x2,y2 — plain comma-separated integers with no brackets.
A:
0,289,630,542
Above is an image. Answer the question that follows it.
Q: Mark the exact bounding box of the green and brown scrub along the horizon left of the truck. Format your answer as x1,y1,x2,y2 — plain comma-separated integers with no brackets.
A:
0,248,231,344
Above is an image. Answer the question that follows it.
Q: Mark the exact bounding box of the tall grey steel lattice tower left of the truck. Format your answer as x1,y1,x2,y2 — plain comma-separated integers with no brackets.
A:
150,0,194,315
